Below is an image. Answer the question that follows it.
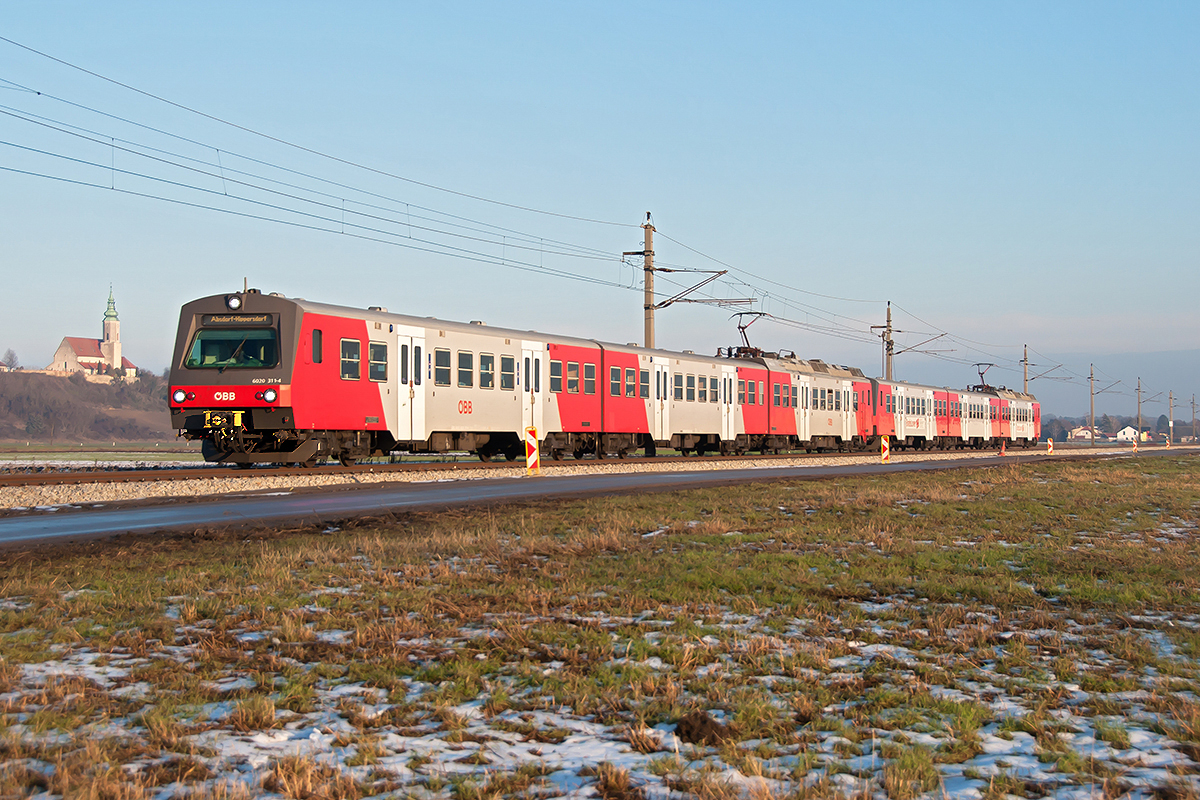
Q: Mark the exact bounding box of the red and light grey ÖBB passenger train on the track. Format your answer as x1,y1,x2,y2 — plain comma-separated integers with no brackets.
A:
168,289,1042,467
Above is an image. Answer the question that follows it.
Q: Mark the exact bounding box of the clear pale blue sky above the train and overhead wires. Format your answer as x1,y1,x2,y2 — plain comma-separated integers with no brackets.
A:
0,1,1200,419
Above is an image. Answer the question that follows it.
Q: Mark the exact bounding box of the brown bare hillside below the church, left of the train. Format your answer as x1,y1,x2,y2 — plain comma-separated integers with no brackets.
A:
0,371,174,441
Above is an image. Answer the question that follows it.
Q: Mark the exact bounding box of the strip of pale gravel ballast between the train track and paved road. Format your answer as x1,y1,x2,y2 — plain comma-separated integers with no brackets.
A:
0,447,1129,511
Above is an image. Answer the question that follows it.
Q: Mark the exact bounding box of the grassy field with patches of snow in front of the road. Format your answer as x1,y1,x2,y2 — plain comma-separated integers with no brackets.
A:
0,456,1200,800
